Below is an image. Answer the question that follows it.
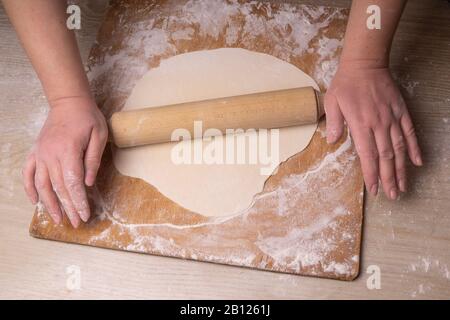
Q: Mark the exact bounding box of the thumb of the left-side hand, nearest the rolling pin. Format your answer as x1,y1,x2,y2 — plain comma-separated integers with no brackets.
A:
84,131,107,186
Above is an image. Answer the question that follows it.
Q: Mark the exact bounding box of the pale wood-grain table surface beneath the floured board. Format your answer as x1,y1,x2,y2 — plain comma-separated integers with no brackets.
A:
0,0,450,299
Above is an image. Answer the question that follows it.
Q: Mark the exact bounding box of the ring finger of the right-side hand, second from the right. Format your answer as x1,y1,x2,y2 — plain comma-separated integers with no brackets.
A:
391,124,406,192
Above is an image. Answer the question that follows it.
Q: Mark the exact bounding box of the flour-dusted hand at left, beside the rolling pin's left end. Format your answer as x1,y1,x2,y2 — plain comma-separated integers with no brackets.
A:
23,97,108,227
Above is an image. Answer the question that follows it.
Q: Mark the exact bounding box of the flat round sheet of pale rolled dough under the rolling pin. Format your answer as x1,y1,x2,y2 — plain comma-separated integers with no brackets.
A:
114,48,318,216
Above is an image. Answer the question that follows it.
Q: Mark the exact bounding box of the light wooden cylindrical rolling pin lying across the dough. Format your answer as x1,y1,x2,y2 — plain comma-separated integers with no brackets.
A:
109,87,324,148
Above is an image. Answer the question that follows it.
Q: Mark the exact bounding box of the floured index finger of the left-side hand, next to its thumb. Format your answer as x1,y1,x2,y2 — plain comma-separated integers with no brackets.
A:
61,157,90,222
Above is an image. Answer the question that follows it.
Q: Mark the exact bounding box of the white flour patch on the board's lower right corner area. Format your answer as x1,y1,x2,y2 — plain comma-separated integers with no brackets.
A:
248,135,357,274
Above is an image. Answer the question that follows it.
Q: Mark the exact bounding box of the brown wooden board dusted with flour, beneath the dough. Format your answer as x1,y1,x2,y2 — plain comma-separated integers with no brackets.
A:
30,0,364,280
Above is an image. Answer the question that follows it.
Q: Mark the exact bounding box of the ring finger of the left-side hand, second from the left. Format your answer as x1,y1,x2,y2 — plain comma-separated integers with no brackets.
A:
34,162,62,224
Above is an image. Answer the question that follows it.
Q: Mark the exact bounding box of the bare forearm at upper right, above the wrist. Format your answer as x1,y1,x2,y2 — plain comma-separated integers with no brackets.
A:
341,0,406,68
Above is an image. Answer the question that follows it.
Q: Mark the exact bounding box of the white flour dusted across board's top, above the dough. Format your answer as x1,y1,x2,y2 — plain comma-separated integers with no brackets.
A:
88,0,344,104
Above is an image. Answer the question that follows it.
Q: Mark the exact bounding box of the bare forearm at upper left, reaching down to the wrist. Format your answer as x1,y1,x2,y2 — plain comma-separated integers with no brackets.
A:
3,0,90,105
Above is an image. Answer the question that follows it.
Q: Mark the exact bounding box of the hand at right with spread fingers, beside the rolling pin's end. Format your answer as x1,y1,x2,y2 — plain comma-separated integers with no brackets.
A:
325,61,422,199
